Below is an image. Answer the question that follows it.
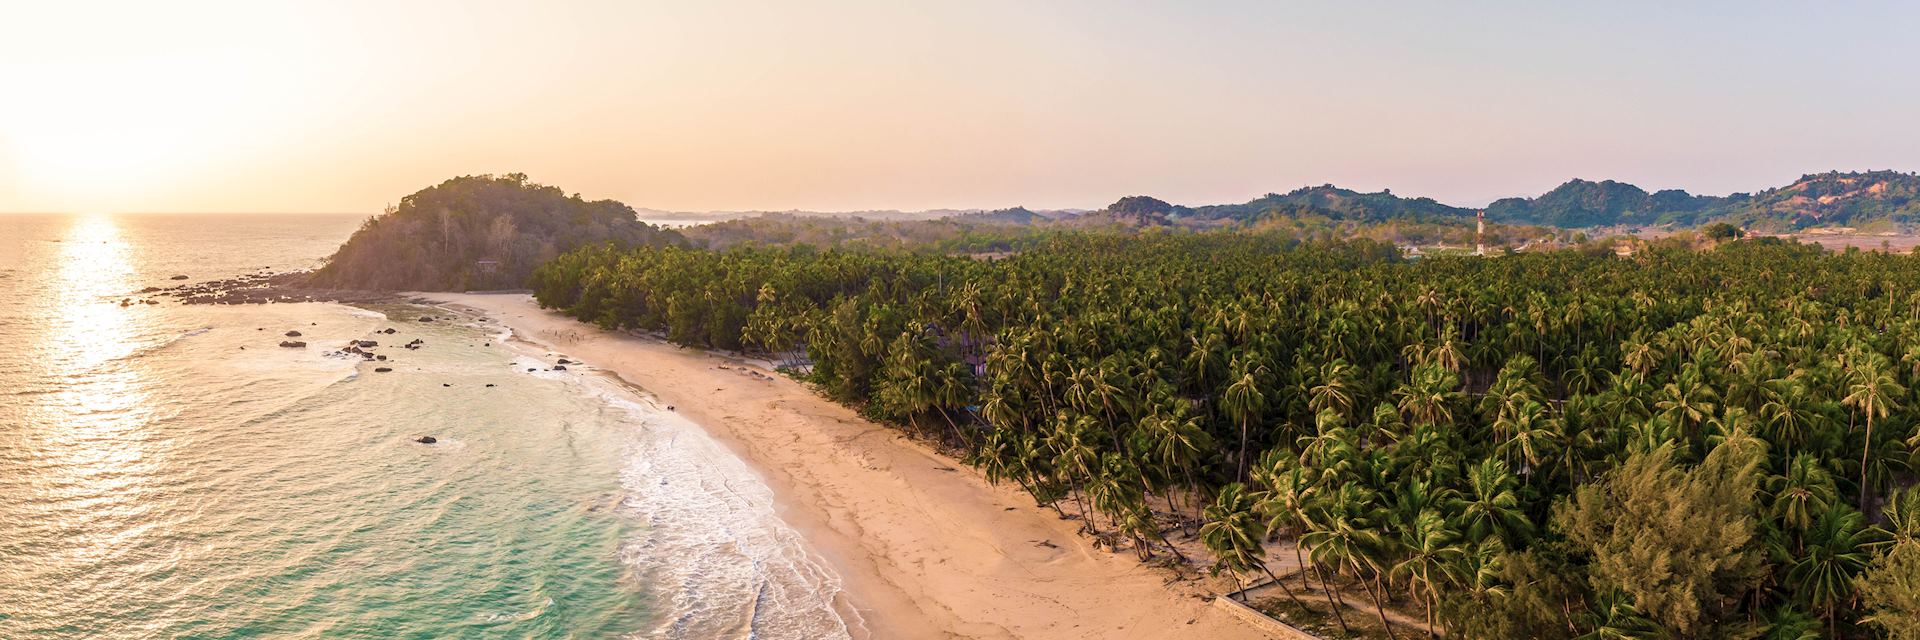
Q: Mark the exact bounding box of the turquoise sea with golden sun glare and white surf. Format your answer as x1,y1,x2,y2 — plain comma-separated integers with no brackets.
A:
0,215,858,638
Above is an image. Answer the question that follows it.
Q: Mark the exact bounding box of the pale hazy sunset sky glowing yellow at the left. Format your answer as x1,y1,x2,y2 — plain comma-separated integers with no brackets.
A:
0,0,1920,213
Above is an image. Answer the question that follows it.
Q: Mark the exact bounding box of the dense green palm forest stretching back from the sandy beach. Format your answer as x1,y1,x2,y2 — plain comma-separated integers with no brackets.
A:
532,233,1920,638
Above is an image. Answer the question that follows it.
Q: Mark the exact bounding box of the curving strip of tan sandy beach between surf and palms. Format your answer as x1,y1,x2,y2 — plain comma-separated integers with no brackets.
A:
420,294,1263,640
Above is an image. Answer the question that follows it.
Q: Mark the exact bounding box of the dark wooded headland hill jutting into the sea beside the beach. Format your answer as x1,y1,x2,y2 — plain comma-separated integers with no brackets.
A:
313,173,682,290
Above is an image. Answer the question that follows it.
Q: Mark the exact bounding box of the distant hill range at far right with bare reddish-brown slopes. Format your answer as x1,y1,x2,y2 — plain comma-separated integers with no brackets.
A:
1486,171,1920,231
